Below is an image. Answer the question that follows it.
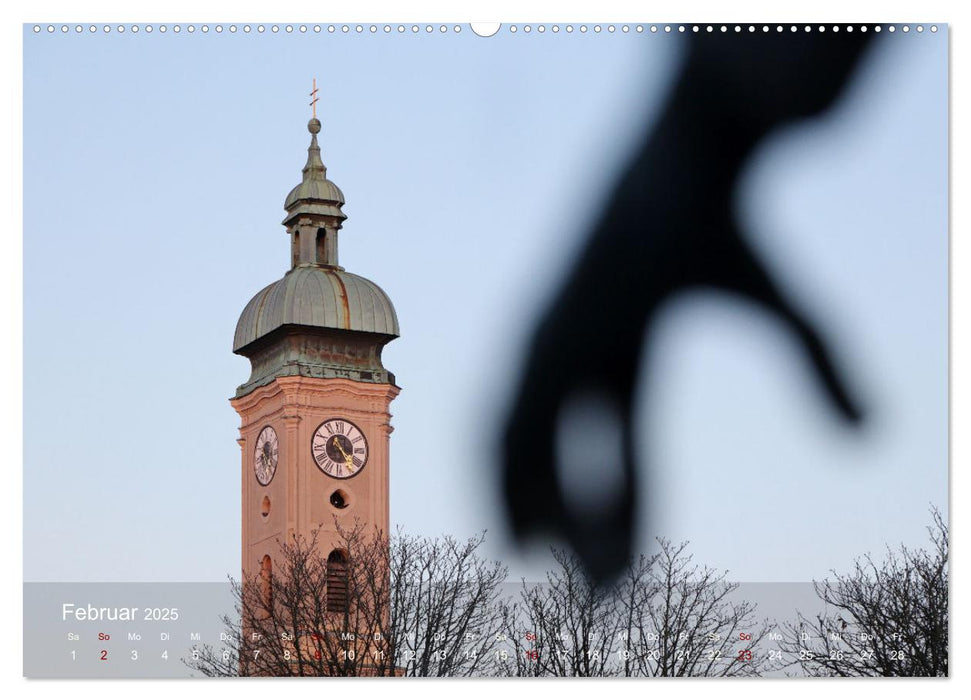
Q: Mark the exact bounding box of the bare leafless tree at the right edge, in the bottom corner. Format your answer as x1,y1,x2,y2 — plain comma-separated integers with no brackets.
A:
780,508,948,676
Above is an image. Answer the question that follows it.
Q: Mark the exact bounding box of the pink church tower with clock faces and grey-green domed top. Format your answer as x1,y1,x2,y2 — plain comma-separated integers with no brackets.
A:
230,117,399,600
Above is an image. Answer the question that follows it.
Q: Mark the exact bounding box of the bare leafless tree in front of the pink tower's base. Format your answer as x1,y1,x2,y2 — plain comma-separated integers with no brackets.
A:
186,525,506,676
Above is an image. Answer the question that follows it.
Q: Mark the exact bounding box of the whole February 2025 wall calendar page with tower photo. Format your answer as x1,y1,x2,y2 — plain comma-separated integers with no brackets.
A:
22,17,950,682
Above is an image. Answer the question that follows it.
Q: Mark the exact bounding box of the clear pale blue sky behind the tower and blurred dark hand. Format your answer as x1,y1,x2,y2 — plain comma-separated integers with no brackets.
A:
24,28,948,581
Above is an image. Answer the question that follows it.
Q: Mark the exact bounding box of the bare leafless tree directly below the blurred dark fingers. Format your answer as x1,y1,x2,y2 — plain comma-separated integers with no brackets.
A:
495,539,772,676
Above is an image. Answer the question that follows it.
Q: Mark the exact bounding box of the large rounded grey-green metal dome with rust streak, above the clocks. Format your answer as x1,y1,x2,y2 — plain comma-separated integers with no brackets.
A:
233,265,398,352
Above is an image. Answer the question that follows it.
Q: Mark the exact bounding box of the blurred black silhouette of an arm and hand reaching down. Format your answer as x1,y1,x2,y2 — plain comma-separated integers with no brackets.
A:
501,26,873,583
